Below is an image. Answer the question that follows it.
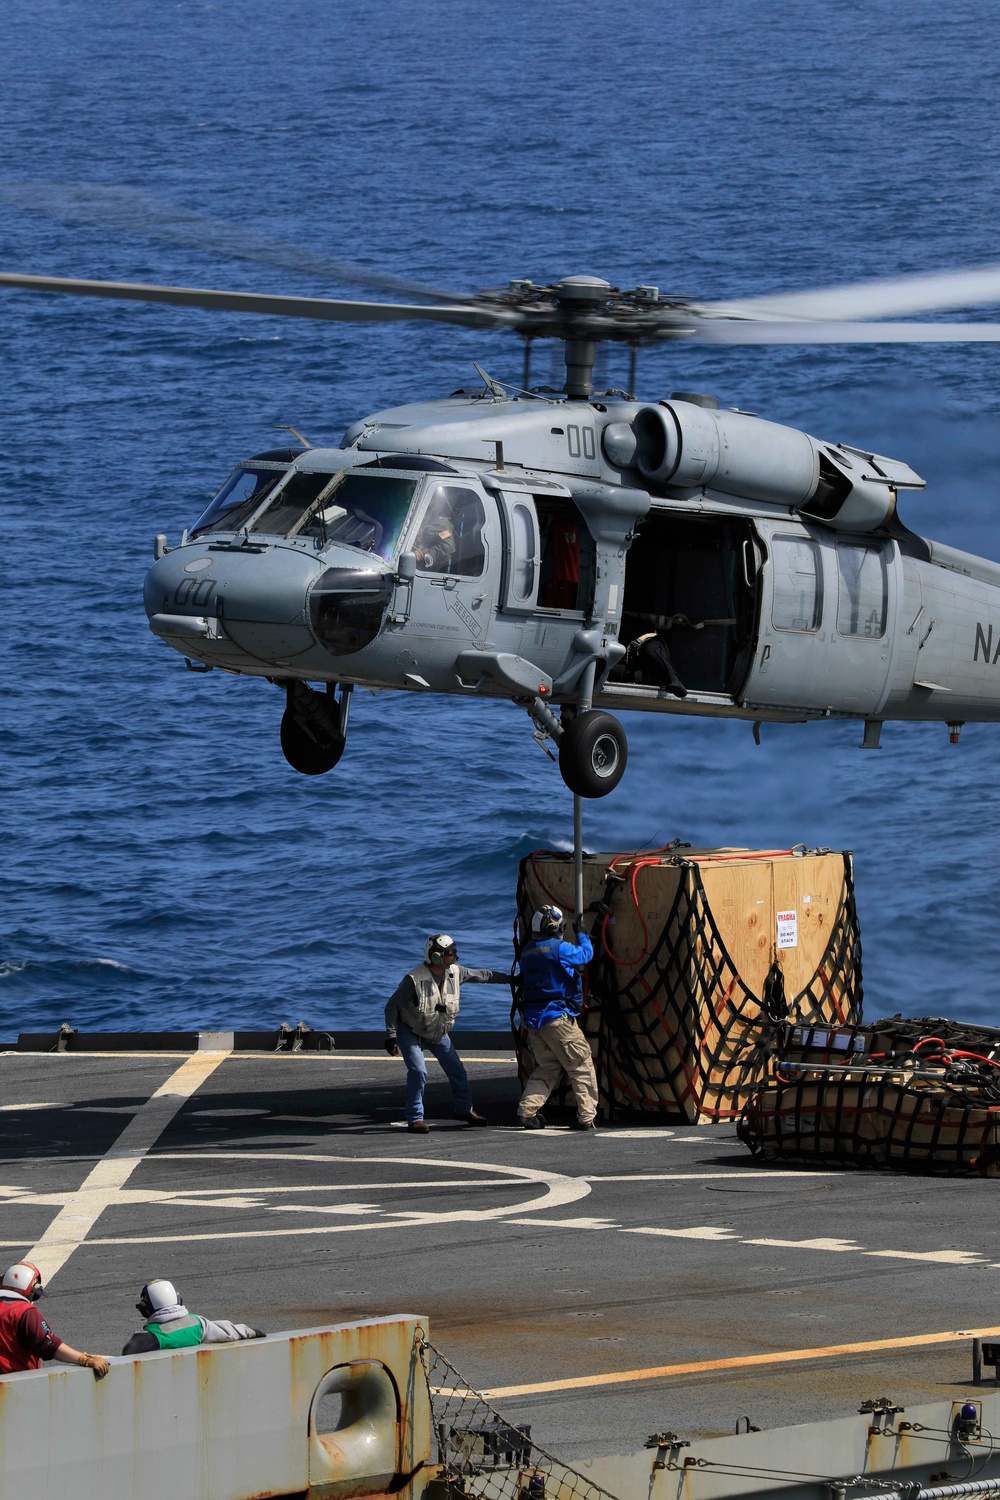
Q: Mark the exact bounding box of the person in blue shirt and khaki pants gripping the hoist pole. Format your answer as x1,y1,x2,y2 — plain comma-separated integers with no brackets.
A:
517,906,597,1130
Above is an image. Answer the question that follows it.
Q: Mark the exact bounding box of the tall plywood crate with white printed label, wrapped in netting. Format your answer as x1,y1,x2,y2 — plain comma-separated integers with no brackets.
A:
517,848,861,1124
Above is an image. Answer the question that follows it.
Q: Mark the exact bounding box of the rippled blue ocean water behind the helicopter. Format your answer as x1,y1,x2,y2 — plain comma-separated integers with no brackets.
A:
0,0,1000,1037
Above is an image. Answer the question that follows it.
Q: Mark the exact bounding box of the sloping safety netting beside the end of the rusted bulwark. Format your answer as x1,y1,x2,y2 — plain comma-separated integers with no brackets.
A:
420,1341,615,1500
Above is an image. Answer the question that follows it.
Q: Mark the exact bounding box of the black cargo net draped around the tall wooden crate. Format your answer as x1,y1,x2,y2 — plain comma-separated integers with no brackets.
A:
511,855,862,1122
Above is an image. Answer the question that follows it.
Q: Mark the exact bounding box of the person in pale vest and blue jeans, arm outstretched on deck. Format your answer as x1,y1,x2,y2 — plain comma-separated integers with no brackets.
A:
385,933,510,1136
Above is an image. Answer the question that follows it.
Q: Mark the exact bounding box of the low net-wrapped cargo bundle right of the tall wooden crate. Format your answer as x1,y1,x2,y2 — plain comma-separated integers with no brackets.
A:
738,1016,1000,1178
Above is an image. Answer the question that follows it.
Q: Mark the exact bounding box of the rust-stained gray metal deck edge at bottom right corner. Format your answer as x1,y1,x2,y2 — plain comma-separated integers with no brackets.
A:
576,1388,1000,1500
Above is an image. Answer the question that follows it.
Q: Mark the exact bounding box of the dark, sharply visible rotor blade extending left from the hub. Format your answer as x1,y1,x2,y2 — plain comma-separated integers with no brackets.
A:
0,272,519,329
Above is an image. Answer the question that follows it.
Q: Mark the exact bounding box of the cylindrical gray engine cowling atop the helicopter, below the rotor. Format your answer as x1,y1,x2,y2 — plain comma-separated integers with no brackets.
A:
631,398,924,531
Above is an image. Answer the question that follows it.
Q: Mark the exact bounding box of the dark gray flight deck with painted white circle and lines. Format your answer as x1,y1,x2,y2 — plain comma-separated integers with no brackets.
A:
0,1053,1000,1457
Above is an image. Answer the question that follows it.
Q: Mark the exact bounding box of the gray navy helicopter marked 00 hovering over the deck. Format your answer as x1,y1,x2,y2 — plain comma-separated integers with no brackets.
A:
0,223,1000,798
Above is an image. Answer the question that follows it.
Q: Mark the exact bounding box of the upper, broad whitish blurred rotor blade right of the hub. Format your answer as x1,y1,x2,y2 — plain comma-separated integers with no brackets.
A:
697,266,1000,323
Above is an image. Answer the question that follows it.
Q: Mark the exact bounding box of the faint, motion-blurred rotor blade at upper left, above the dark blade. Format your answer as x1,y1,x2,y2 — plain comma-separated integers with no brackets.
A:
0,182,468,305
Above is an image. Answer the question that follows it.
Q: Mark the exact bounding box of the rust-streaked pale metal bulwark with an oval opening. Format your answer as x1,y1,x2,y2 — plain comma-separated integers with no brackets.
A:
0,1316,436,1500
